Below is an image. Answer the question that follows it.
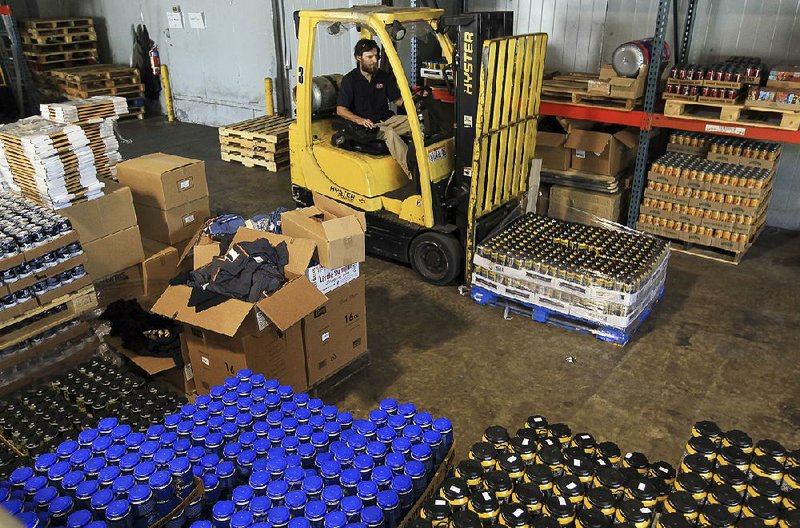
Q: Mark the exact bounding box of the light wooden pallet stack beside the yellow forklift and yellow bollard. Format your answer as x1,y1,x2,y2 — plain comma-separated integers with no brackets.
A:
219,116,294,172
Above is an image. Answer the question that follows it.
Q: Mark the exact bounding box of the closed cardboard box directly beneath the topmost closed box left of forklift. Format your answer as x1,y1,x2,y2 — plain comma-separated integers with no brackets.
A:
134,196,211,245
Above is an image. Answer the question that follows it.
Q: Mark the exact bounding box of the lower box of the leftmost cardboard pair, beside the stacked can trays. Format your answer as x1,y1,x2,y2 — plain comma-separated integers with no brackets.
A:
81,224,144,279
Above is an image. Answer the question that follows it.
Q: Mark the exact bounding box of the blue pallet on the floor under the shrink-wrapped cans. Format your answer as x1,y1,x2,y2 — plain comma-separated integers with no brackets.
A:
470,286,664,346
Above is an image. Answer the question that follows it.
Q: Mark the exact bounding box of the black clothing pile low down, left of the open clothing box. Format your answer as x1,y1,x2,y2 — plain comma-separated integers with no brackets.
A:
100,300,183,366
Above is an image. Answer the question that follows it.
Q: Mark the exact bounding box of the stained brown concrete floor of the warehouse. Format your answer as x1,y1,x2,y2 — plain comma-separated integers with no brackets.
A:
120,118,800,464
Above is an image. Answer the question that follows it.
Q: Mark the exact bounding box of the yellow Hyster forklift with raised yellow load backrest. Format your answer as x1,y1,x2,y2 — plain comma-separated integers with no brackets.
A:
289,6,547,284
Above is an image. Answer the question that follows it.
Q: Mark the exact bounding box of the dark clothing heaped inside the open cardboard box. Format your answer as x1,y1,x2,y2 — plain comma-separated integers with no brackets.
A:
171,238,289,312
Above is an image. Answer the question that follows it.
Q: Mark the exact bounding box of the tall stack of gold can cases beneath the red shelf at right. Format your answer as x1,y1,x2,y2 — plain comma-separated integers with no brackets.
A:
637,133,780,252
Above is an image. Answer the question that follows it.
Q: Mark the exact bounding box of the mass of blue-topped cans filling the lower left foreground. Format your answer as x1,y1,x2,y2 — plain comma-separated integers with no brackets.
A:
0,370,453,528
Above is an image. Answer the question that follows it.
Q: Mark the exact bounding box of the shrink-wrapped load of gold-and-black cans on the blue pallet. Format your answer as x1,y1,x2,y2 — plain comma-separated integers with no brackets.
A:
472,214,669,329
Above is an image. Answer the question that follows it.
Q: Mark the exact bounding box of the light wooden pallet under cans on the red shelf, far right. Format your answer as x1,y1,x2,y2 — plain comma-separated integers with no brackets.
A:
664,101,800,130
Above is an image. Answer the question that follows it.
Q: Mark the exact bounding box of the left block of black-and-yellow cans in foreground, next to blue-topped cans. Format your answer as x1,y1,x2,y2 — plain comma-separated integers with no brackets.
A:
414,415,675,528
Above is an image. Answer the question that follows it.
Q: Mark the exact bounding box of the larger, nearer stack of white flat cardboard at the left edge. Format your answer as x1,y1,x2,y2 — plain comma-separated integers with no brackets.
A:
0,116,104,209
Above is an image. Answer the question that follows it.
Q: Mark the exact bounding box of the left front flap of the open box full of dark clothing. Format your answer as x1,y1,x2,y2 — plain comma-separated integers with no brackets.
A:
151,285,253,337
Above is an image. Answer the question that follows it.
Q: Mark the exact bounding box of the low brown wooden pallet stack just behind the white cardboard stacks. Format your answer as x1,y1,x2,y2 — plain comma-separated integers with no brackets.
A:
51,64,144,119
